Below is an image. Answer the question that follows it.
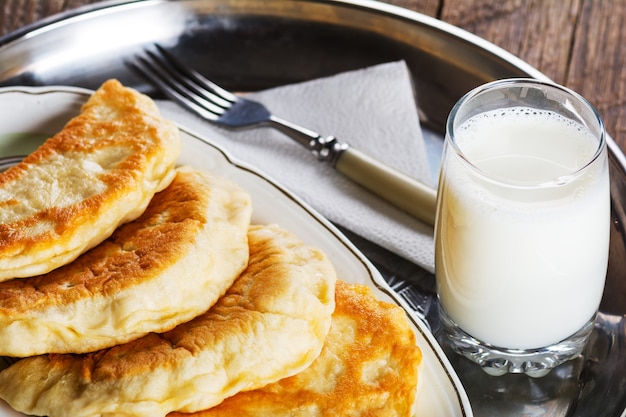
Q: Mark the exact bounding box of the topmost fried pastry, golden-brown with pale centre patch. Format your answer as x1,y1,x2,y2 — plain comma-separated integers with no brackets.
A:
0,80,181,281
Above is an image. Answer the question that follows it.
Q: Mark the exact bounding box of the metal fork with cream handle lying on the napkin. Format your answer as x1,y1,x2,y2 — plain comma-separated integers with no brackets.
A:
129,45,436,225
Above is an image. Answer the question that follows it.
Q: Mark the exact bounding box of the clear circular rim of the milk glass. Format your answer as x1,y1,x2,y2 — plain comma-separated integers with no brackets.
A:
445,78,607,189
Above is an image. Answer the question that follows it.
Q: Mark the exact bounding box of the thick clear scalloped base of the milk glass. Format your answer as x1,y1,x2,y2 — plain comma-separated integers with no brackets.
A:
439,307,595,378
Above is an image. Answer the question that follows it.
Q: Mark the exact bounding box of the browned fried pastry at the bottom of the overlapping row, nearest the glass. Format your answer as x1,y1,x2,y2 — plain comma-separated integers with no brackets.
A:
168,280,422,417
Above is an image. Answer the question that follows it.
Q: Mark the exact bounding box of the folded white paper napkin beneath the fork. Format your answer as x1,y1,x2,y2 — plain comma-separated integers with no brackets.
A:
158,61,434,272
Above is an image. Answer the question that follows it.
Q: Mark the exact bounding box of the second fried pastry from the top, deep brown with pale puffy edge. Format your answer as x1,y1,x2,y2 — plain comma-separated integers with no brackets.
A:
0,168,252,357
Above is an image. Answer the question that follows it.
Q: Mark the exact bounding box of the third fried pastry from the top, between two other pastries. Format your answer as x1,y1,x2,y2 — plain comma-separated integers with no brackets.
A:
0,226,336,417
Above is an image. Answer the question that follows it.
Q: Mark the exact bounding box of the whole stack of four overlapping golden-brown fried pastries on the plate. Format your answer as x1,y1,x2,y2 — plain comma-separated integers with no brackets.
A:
0,80,421,417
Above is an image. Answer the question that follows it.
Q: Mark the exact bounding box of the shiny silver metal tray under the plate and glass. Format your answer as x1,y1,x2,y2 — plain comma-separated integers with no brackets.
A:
0,0,626,417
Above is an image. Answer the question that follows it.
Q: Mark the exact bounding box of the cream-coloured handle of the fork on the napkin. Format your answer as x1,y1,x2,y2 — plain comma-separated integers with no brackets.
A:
334,146,437,225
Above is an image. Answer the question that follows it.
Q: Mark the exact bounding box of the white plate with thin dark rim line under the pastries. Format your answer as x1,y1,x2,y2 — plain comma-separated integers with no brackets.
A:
0,87,473,417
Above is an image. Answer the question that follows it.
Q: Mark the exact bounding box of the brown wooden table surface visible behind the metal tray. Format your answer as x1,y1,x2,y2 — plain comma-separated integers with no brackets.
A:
0,0,626,150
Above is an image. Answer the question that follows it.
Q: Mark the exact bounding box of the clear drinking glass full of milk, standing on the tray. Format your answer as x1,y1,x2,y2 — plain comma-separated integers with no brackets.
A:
435,79,610,377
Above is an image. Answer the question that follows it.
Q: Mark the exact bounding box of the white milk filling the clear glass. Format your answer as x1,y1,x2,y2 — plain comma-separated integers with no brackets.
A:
435,107,610,349
